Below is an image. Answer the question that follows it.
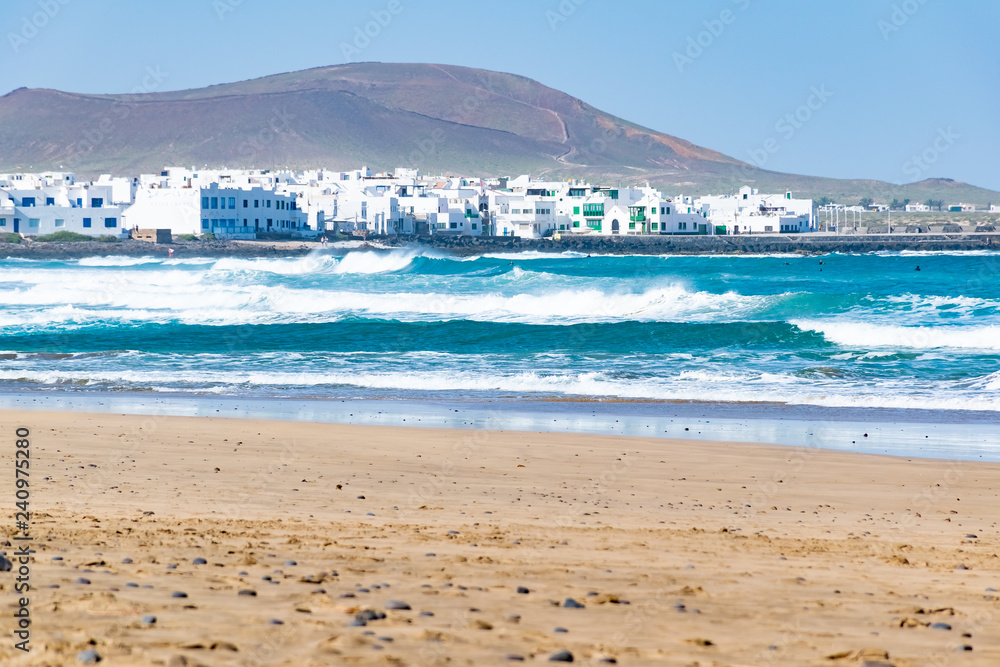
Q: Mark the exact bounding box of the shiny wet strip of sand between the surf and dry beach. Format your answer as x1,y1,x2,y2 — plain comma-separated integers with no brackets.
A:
0,392,1000,462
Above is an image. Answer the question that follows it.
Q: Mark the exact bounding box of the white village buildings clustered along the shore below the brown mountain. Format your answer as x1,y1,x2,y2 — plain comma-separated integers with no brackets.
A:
0,167,817,239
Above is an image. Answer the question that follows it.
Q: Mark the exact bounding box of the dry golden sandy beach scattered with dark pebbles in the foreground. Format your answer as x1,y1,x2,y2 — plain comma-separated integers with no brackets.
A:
0,412,1000,667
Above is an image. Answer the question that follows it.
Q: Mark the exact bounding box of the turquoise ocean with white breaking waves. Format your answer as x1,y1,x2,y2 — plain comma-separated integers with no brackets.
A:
0,248,1000,462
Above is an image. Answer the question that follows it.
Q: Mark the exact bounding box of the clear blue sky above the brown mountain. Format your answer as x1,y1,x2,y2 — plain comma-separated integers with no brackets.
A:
0,0,1000,190
